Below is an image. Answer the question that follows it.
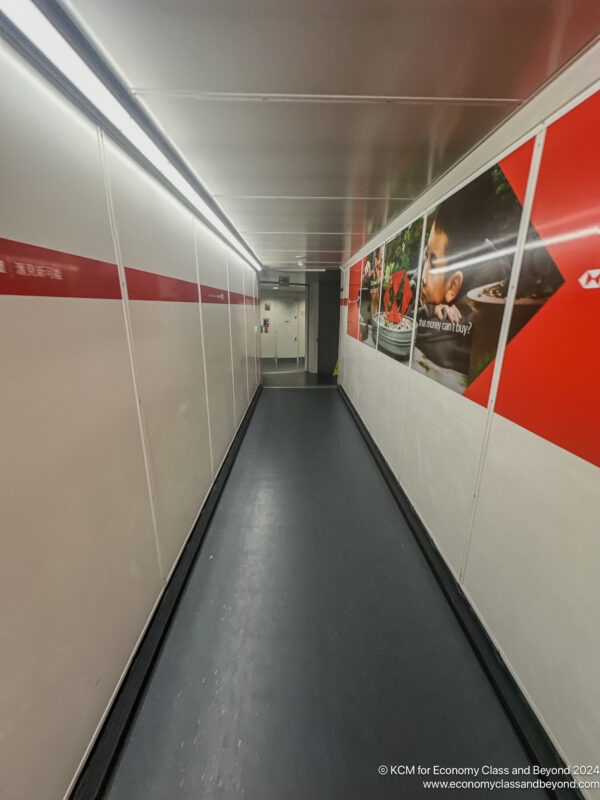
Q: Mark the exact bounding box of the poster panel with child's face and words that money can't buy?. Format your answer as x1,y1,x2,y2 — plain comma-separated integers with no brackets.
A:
411,141,536,406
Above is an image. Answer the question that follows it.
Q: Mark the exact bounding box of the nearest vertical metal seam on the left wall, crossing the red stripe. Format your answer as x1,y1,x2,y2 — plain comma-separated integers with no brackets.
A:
96,126,165,584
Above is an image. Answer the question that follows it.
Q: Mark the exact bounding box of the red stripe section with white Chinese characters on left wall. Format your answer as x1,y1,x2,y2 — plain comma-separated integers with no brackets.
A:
0,238,121,300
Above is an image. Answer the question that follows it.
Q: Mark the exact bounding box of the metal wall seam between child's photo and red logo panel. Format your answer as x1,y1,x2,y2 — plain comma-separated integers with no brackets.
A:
458,127,546,585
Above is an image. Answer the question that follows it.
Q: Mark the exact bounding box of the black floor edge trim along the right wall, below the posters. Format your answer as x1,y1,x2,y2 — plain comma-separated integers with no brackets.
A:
338,386,585,800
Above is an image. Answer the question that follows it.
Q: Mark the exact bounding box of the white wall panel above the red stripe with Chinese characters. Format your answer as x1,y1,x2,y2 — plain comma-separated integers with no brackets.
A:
0,40,115,262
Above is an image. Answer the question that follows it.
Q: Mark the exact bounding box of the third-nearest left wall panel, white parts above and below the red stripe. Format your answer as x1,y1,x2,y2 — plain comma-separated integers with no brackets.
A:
196,223,236,472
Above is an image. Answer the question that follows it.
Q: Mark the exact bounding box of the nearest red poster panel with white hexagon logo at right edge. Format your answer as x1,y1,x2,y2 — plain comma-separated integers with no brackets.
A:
495,92,600,466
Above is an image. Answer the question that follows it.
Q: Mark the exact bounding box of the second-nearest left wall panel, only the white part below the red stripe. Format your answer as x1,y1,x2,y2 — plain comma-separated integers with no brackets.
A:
119,300,212,575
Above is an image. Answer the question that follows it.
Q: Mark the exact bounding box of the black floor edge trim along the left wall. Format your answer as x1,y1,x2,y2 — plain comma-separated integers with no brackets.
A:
70,385,263,800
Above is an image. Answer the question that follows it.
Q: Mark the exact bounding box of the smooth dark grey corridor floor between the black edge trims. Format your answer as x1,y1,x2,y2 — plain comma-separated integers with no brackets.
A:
107,390,545,800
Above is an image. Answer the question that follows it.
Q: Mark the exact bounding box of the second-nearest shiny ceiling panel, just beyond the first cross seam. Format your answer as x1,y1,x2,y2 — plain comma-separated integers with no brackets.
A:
135,96,514,198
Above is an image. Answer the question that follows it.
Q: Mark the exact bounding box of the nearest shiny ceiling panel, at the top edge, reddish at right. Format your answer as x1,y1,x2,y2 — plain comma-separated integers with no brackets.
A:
70,0,600,98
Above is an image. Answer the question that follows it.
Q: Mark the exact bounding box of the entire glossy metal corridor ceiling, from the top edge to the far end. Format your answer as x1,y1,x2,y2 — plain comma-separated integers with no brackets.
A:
65,0,600,268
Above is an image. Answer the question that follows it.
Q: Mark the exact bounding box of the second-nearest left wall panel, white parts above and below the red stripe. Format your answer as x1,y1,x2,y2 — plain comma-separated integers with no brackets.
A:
107,145,212,574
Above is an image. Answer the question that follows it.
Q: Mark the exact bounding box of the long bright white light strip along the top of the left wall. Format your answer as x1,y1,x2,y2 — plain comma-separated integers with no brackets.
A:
0,0,261,271
